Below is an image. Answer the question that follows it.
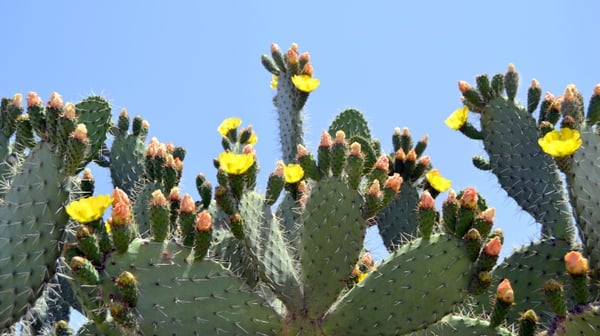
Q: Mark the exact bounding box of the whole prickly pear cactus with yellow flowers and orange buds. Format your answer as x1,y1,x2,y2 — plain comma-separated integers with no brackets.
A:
0,44,600,335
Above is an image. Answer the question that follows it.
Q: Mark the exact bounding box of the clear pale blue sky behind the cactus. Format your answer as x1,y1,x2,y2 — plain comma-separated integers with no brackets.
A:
0,0,600,253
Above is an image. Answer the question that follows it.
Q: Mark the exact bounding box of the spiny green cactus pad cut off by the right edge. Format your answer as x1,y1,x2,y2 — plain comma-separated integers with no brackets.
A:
566,129,600,277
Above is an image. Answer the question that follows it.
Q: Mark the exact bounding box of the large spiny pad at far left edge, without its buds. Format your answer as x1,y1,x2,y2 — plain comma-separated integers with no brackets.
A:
0,142,70,329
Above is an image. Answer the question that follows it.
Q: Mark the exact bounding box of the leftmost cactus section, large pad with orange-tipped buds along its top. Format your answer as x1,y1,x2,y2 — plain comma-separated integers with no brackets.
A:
0,92,110,329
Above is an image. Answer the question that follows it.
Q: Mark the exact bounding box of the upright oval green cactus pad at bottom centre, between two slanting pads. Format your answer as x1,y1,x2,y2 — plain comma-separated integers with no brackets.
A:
299,177,366,319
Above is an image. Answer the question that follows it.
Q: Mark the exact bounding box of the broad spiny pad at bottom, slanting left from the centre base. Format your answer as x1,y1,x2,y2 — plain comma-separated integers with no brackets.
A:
102,239,282,335
